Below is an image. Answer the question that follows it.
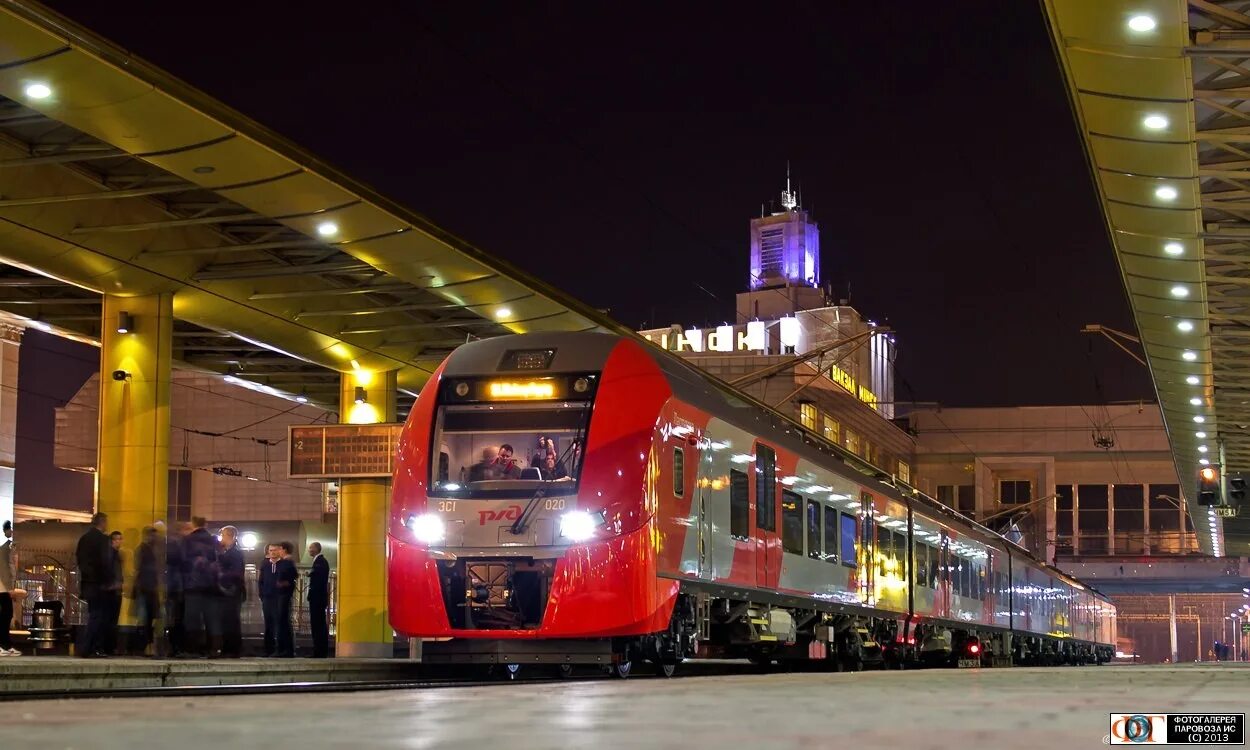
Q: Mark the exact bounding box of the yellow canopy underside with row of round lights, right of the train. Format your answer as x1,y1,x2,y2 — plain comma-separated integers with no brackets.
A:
1043,0,1250,556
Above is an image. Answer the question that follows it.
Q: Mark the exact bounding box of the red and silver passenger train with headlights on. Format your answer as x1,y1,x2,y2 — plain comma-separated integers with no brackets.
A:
389,333,1115,676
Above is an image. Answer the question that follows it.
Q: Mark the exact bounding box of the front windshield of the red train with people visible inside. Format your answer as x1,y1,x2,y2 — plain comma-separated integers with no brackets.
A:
430,401,590,498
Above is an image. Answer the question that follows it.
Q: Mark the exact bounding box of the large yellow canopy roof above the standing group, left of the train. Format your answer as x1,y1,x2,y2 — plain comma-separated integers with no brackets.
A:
0,3,624,408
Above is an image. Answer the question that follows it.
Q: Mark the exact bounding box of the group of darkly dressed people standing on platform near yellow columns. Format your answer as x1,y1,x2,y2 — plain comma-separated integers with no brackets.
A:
76,513,330,659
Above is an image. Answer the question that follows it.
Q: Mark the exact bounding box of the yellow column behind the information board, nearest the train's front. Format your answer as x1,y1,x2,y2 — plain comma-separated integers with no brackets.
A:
335,370,396,658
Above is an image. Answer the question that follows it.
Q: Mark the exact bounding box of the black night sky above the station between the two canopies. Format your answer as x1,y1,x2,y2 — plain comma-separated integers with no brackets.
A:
29,1,1153,406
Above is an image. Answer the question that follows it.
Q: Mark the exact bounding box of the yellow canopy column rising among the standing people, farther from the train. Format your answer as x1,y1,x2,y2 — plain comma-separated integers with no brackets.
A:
96,294,174,625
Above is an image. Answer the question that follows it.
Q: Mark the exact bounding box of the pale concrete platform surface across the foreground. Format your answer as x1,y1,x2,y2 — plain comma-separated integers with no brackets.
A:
0,664,1250,750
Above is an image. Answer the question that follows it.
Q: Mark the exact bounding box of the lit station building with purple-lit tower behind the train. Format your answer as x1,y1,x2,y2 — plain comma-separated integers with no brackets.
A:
640,181,915,481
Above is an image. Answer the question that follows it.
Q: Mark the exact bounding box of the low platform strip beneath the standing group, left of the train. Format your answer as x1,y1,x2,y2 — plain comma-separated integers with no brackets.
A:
0,656,419,695
